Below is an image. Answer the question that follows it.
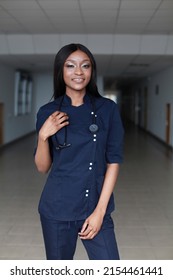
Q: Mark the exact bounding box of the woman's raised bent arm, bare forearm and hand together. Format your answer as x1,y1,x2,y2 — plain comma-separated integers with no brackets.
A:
35,111,69,173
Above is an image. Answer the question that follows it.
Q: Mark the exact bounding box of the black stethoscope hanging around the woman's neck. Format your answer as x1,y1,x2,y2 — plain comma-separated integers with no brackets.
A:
55,95,99,150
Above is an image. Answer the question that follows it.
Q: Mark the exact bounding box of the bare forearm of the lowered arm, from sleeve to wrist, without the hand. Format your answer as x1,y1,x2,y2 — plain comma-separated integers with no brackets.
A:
96,163,119,215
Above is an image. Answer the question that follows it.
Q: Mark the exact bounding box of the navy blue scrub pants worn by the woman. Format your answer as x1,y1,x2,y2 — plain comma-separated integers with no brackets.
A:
41,215,119,260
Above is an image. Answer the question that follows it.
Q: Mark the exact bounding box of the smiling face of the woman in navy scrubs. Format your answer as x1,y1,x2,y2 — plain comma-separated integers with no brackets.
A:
63,50,92,94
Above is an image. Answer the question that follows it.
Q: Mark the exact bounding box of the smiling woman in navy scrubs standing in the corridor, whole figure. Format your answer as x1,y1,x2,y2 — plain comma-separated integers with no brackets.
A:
35,44,124,260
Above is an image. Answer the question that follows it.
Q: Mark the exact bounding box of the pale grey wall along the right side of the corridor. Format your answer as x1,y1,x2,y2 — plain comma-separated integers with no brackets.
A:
129,67,173,147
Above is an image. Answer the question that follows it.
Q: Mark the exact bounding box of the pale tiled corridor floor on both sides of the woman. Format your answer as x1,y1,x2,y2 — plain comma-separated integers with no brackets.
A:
0,123,173,260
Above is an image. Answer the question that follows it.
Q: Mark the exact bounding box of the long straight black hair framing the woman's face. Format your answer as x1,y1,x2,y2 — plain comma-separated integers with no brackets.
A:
53,43,100,99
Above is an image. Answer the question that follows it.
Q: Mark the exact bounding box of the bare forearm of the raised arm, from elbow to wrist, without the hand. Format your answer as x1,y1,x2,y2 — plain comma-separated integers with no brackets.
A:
35,136,52,173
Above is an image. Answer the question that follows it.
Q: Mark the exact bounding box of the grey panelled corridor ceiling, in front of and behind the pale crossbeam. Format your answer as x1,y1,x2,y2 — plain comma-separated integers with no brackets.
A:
0,0,173,88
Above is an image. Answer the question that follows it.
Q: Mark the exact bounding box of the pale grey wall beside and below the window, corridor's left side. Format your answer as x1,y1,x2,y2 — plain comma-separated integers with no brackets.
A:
0,64,35,144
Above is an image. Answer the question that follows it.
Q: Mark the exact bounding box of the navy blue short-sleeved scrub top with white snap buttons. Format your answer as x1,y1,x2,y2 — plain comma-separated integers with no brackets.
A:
36,94,124,221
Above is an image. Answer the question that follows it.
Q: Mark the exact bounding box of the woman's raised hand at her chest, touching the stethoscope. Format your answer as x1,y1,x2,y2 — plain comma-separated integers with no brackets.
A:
39,111,69,141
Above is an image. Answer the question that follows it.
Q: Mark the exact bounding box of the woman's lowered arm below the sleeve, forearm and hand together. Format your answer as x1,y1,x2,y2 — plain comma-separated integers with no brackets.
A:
79,163,119,239
